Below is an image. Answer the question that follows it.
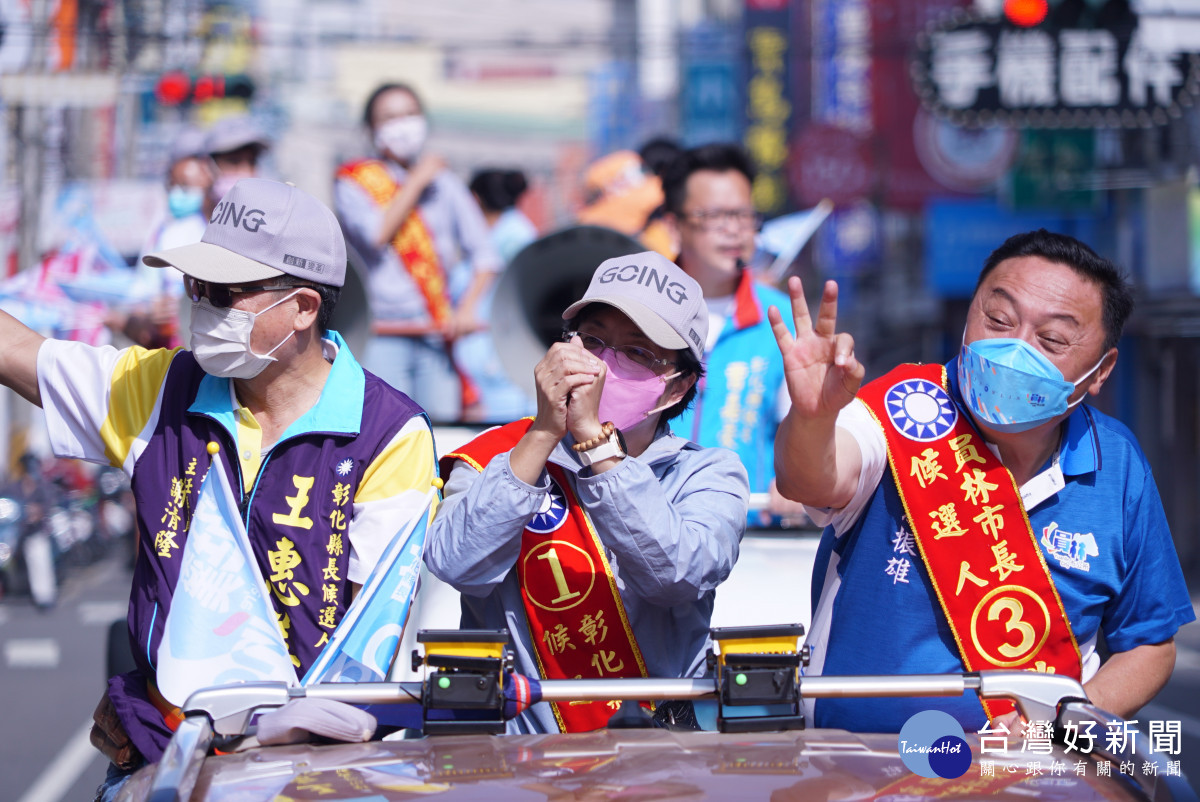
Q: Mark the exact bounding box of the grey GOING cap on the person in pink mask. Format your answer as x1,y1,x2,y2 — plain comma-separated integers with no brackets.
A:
563,251,708,360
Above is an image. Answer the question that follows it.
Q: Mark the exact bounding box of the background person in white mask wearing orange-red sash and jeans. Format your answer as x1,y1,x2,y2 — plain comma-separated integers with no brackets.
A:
334,84,503,420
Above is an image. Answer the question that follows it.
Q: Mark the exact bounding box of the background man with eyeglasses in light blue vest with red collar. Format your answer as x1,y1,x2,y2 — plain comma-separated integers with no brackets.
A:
662,143,805,525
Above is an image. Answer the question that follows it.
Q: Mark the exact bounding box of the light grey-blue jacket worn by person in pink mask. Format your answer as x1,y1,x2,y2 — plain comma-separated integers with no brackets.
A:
425,427,750,732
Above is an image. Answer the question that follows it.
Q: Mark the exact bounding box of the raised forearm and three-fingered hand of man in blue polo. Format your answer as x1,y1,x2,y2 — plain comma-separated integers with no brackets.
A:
767,276,864,508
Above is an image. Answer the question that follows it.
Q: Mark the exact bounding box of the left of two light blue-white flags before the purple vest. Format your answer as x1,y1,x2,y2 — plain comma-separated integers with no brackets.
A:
156,455,296,705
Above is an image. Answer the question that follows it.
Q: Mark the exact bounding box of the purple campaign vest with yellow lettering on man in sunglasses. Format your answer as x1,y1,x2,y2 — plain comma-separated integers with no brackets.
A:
109,351,424,761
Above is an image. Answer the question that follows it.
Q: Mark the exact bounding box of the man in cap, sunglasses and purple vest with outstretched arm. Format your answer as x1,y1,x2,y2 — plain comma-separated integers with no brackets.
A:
0,179,436,783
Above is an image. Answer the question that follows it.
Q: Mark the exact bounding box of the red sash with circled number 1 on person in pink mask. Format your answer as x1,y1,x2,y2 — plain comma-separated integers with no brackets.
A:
440,418,647,732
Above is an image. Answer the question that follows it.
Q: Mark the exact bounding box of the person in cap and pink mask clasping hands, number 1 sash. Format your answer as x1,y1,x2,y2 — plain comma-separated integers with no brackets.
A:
425,252,750,732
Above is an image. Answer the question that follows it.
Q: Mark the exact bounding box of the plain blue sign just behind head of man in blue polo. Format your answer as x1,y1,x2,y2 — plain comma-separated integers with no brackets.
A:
925,199,1098,298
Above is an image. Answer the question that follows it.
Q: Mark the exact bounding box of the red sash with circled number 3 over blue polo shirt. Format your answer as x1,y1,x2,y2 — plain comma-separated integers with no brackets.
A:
858,365,1081,718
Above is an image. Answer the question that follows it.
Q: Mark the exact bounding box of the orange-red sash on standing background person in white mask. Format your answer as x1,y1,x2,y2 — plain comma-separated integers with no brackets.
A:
337,158,480,408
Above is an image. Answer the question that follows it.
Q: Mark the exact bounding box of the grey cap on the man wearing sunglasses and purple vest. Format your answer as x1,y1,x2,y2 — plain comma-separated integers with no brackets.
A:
142,178,346,287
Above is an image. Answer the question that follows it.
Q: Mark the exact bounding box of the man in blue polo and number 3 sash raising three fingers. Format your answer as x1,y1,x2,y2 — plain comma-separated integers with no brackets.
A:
770,229,1195,731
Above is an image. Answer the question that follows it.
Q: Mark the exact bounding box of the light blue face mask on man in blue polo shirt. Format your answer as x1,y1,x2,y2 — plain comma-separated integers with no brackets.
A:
959,337,1104,433
